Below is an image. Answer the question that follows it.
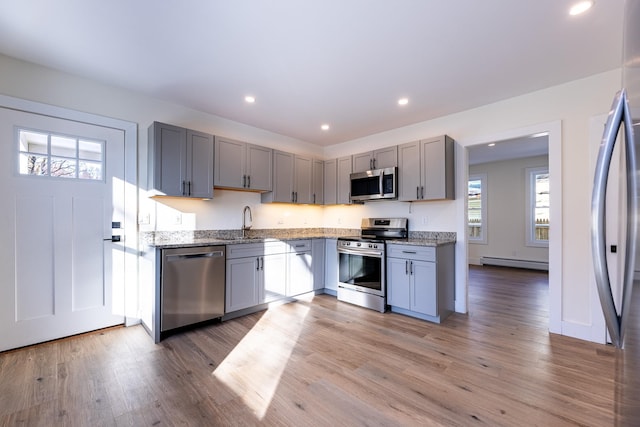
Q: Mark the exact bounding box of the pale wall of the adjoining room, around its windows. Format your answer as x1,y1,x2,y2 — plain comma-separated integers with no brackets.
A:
469,156,553,264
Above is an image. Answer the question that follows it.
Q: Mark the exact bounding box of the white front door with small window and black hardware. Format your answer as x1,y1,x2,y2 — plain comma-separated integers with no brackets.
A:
0,108,125,351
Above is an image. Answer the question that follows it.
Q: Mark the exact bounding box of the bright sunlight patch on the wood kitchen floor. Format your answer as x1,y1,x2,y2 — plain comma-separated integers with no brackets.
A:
212,304,309,420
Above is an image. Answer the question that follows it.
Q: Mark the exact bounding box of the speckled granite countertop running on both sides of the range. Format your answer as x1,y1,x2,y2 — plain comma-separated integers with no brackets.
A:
140,228,456,249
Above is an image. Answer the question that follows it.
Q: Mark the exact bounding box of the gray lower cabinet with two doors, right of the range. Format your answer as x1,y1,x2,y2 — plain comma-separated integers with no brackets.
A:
387,244,455,323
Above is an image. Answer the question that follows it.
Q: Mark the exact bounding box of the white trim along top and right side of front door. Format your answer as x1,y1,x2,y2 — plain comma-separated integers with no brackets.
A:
0,94,140,326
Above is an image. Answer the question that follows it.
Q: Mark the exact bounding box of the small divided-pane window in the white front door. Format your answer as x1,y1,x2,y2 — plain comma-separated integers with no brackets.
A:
16,129,104,181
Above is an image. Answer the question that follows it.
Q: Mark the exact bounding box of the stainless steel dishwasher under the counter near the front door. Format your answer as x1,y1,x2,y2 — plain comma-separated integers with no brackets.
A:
160,246,225,332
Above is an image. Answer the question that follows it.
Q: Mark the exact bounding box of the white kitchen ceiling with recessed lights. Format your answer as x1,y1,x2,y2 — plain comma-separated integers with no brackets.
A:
0,0,623,146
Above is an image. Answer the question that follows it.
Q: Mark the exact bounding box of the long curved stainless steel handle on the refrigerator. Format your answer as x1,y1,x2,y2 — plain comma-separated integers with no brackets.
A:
591,89,637,348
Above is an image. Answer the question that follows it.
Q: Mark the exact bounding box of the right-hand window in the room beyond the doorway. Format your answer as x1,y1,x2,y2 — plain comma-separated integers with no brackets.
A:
526,167,550,247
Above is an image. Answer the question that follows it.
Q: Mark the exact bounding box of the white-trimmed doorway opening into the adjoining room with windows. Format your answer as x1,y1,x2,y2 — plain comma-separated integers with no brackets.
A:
458,122,562,333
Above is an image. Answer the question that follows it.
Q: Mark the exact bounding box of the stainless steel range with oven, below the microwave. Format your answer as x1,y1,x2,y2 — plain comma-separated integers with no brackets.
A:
338,218,409,313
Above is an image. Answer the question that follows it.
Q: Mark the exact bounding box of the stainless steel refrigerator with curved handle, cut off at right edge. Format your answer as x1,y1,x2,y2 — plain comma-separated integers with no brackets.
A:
591,0,640,426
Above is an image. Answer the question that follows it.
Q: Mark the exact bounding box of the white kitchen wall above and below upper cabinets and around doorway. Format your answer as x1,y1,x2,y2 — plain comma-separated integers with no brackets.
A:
0,52,621,344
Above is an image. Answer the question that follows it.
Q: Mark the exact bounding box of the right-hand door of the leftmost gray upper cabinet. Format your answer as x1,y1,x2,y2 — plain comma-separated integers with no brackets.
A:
186,130,214,199
